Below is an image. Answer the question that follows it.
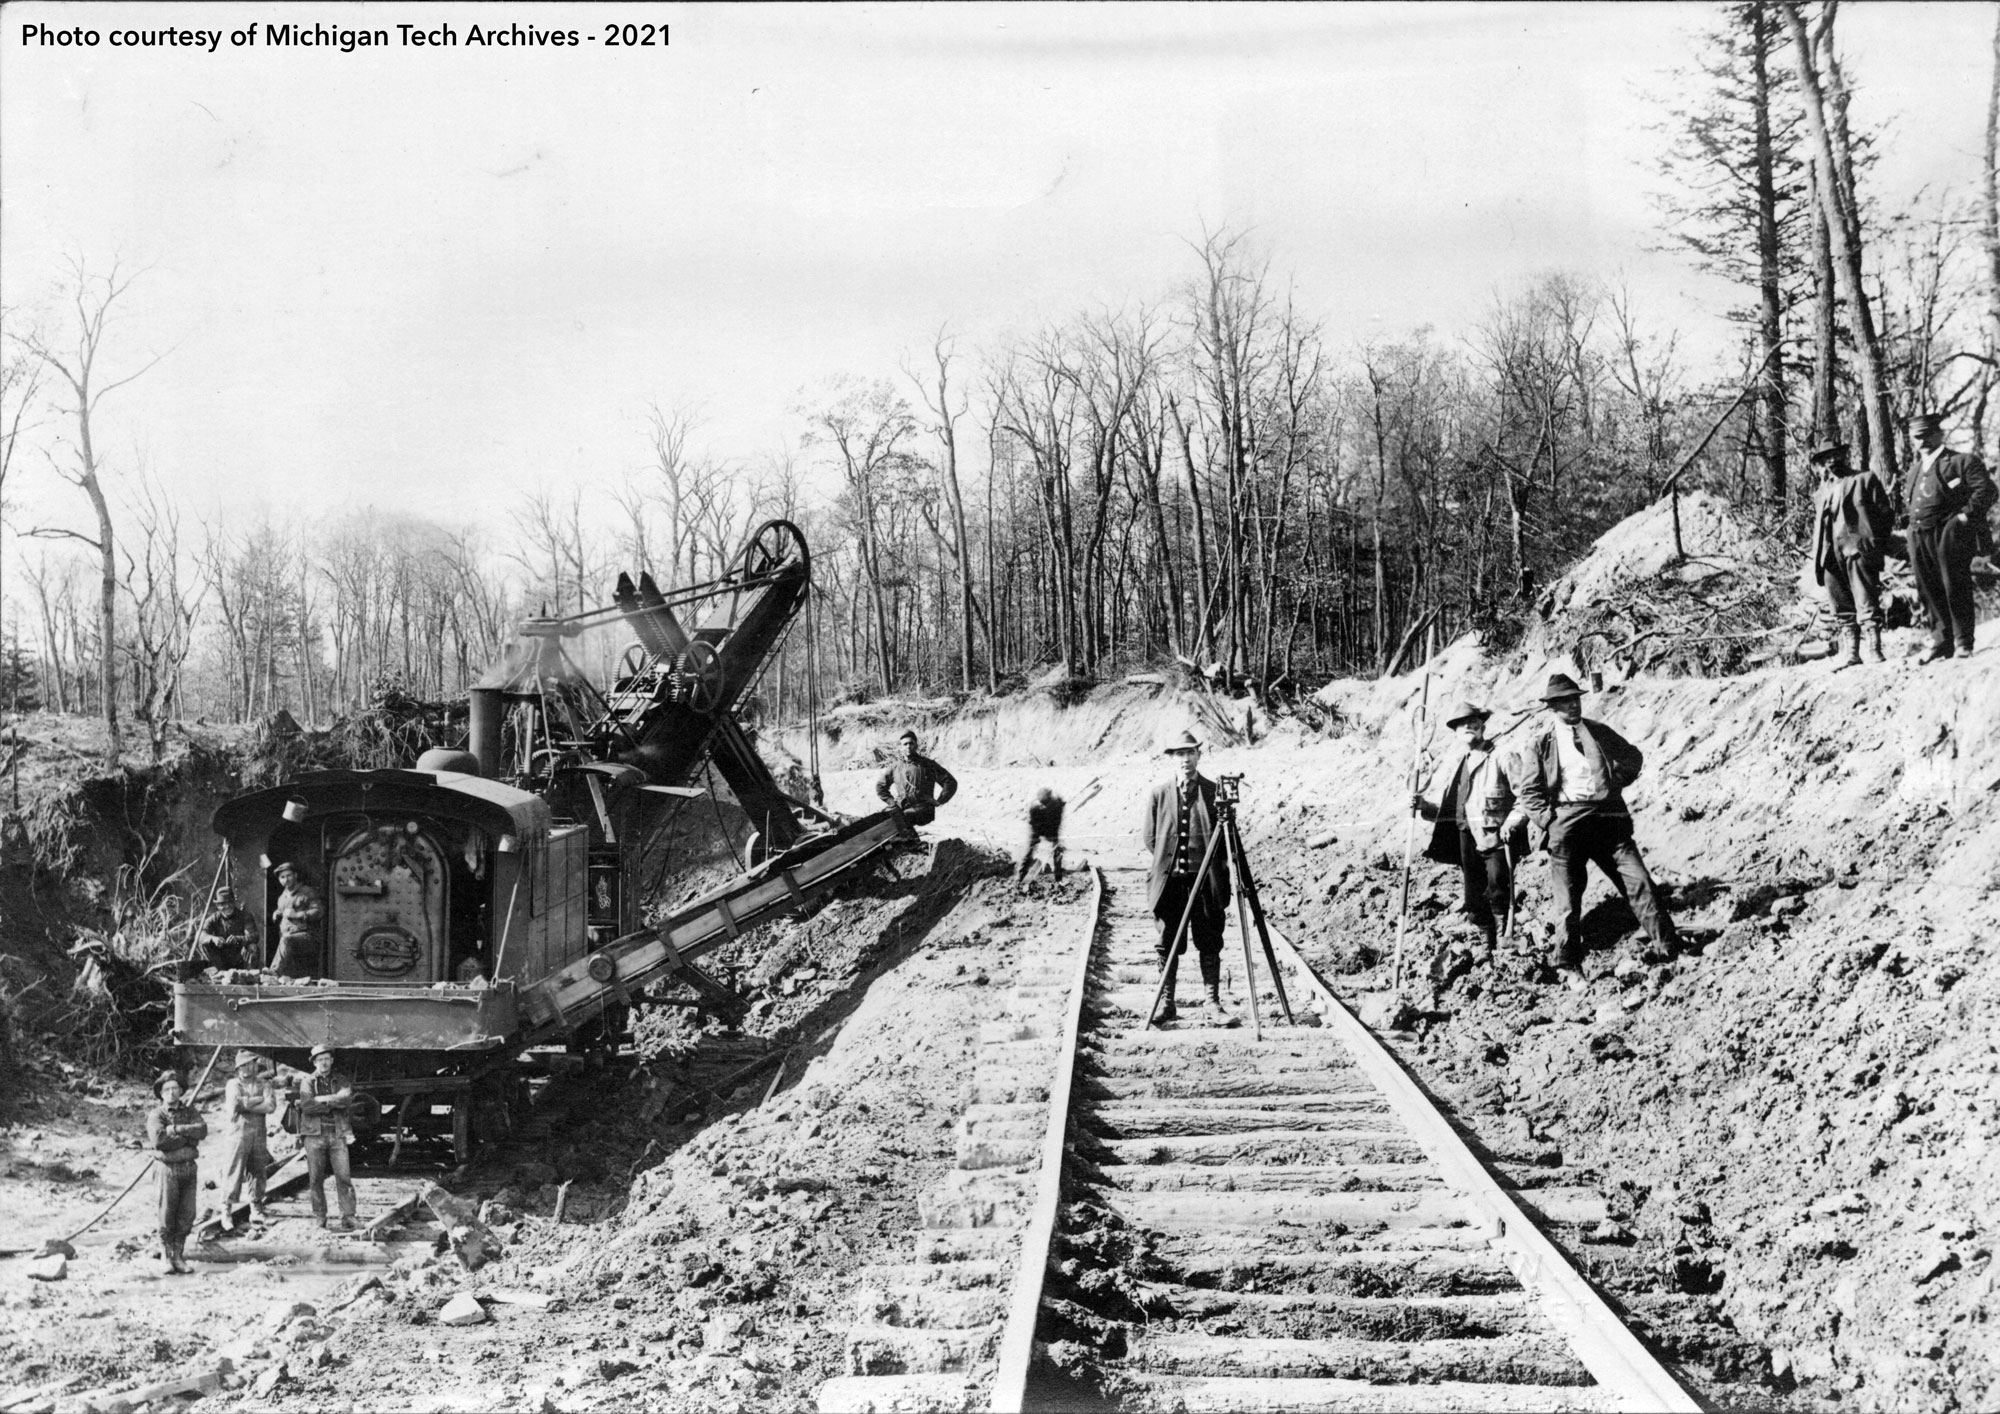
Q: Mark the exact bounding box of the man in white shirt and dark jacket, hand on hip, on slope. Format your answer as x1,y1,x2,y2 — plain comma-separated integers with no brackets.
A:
1508,672,1674,972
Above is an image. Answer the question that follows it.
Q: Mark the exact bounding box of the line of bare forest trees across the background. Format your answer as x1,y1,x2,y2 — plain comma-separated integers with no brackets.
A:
0,2,2000,764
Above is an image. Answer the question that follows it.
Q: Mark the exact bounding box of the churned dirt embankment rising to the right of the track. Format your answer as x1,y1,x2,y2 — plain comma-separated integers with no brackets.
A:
1244,648,2000,1408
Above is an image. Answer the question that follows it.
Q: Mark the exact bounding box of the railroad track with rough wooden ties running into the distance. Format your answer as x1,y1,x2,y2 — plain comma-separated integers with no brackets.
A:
820,870,1702,1414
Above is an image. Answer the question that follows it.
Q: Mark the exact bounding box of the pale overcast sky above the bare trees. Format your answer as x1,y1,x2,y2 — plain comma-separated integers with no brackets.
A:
0,4,1994,558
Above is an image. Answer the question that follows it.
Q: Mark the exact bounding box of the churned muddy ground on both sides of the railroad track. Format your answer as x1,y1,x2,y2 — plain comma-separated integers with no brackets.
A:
0,624,2000,1410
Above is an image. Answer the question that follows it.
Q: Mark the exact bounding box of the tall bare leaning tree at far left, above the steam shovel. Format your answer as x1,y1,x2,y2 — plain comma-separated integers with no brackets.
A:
20,258,164,760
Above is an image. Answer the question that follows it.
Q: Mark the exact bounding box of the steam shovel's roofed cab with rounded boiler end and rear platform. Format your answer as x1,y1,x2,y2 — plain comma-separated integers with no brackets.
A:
174,770,588,1162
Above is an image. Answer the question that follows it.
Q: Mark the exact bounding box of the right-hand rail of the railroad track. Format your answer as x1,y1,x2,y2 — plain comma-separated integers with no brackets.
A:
1270,924,1706,1414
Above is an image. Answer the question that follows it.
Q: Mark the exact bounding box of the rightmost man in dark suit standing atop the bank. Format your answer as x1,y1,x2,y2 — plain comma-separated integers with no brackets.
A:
1904,412,2000,662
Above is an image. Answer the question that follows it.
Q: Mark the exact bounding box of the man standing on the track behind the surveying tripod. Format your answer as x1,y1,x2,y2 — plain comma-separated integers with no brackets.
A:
1140,732,1234,1024
